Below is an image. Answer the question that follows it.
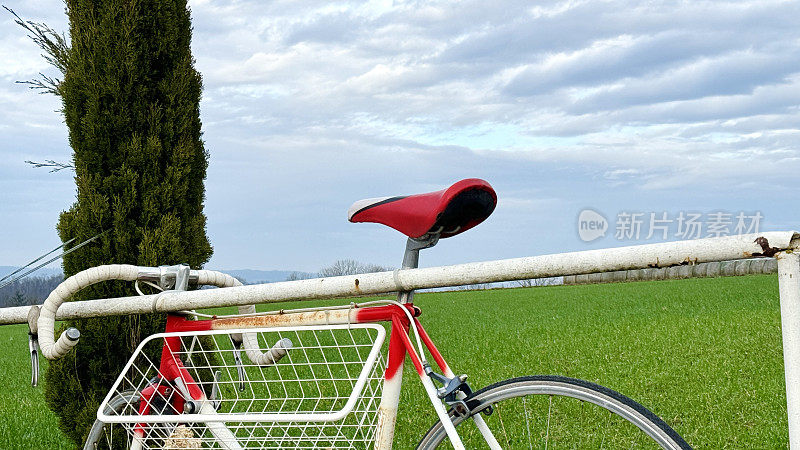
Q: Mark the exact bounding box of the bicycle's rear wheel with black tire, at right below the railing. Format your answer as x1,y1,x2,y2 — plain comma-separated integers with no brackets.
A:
418,376,691,450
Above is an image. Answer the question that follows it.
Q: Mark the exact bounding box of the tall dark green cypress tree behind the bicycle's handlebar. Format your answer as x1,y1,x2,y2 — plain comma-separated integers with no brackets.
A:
14,0,212,444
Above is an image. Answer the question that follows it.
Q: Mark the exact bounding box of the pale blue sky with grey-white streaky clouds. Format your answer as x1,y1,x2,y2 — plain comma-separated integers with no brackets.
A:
0,0,800,271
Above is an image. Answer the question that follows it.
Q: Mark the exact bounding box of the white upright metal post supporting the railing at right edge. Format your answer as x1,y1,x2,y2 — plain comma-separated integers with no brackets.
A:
776,253,800,450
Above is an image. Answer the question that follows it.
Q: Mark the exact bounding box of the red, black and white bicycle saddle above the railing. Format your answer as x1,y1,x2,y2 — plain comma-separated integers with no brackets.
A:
347,178,497,238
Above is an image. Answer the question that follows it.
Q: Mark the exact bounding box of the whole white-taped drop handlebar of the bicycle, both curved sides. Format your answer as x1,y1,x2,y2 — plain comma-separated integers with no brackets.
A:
37,264,282,365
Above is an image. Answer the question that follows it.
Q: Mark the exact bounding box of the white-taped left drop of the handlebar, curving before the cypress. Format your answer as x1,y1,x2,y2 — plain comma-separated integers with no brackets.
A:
36,264,139,359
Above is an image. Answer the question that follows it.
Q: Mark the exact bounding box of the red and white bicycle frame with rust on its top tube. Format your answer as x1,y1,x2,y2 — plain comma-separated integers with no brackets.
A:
135,303,488,449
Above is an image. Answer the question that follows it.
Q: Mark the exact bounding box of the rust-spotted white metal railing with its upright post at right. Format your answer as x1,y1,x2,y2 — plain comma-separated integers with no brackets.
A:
0,231,800,449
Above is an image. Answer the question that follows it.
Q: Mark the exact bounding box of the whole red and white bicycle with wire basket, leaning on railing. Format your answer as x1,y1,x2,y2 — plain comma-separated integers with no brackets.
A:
37,179,691,450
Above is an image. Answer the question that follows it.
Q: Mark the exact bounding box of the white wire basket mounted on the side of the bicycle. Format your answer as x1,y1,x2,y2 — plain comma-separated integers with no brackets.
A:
97,324,386,449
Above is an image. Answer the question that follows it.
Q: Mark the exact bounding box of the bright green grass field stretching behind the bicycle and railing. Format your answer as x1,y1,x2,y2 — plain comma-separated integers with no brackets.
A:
0,275,788,449
